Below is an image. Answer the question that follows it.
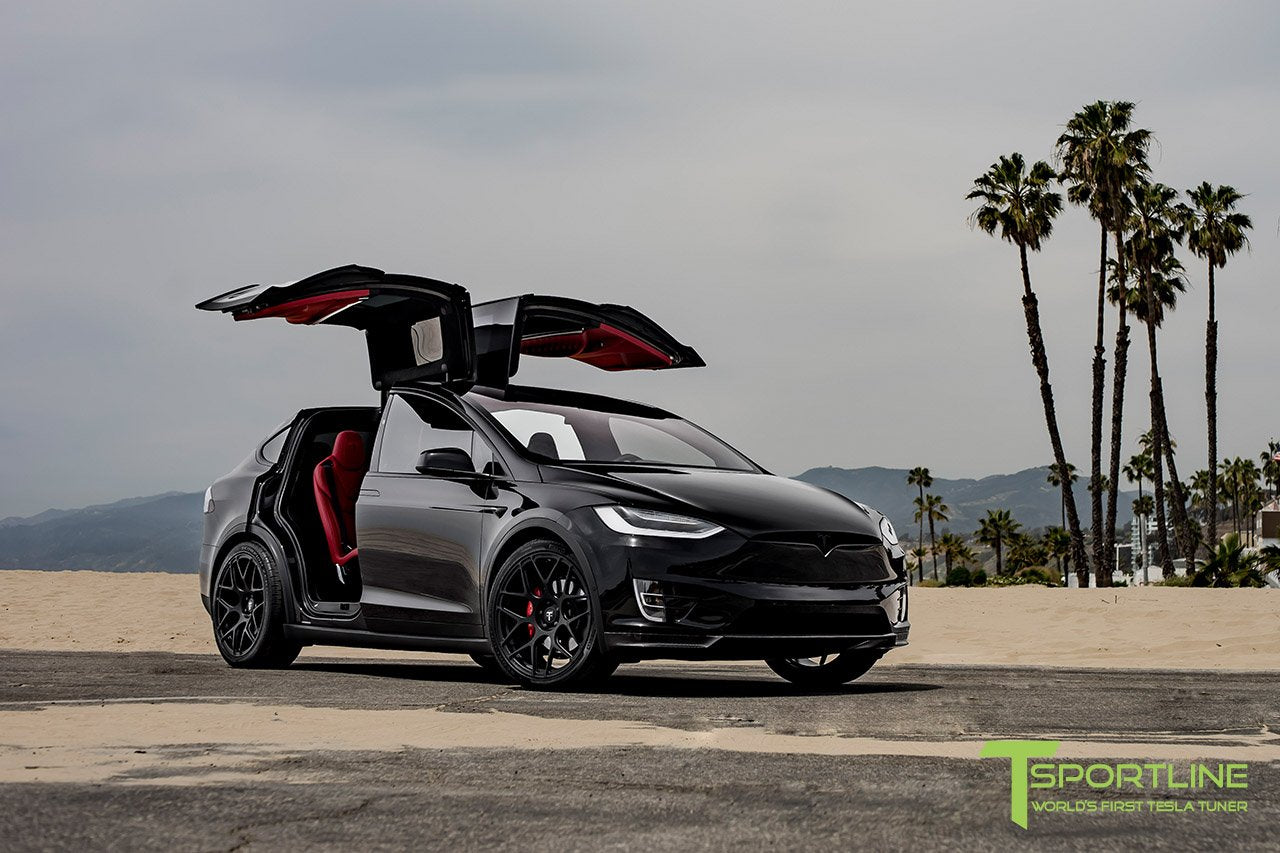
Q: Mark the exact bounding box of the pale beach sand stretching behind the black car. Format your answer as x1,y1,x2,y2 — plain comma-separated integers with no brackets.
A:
0,571,1280,670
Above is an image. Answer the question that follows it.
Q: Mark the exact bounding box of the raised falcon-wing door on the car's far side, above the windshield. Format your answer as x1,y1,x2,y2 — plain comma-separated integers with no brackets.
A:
471,295,707,387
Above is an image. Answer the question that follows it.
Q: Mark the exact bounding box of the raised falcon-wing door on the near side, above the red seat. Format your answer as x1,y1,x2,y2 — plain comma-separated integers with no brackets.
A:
196,265,475,391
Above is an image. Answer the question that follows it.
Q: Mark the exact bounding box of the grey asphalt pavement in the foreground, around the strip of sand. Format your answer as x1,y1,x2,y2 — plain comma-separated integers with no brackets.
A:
0,651,1280,852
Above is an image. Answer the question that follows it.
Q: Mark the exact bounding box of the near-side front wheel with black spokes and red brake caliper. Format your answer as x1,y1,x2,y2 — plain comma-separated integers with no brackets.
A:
485,539,618,689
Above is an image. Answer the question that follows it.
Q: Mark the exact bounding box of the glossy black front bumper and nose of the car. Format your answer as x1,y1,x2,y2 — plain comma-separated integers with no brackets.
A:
584,507,910,660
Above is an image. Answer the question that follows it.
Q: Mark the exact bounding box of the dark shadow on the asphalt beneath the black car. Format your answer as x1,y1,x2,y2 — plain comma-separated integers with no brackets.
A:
289,660,945,699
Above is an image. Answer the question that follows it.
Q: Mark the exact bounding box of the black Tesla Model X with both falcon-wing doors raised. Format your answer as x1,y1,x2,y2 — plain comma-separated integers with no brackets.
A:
197,266,909,686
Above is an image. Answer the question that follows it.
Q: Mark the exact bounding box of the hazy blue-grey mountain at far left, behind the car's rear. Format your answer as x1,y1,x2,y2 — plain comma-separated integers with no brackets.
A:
0,492,204,571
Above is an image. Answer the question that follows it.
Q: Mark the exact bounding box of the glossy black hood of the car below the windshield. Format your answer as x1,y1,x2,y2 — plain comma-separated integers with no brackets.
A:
545,466,881,540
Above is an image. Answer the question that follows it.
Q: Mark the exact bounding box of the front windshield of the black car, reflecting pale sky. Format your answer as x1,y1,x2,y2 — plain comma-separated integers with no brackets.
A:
468,394,756,471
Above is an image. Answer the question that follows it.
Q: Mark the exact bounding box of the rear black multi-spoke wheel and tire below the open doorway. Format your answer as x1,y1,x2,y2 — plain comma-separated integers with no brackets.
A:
210,542,302,669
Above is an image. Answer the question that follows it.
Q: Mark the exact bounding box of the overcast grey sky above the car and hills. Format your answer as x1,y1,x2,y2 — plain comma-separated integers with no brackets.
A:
0,0,1280,517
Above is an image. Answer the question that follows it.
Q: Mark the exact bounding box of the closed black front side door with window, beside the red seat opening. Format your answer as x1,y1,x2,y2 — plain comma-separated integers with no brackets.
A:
356,393,500,637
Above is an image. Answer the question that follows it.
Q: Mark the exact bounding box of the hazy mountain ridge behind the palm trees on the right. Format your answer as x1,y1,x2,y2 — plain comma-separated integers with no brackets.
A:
796,467,1138,538
